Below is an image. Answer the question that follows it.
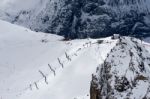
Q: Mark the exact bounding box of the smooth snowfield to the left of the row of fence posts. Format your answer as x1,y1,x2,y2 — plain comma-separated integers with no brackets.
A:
0,21,67,97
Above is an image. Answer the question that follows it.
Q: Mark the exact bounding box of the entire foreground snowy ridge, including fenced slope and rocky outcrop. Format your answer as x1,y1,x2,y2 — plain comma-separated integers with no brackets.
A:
0,21,150,99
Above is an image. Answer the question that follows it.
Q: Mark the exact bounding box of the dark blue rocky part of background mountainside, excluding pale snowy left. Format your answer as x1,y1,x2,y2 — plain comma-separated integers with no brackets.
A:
44,0,150,38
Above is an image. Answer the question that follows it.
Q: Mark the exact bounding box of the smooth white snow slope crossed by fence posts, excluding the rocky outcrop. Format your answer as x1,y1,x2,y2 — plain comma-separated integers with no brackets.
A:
0,21,117,99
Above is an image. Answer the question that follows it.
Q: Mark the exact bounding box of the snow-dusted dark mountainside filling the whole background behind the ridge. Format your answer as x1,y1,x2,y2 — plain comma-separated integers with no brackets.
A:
0,0,150,38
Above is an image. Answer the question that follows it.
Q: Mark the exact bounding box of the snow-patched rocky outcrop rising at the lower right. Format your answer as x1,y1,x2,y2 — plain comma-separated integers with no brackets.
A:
91,37,150,99
